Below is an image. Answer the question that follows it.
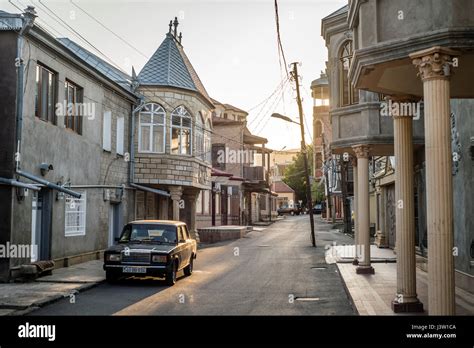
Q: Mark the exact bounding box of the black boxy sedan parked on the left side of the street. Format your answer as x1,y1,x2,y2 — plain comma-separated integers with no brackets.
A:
104,220,197,285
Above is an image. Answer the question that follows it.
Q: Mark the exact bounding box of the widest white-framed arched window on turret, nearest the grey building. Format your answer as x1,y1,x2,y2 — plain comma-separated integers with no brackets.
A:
138,103,166,153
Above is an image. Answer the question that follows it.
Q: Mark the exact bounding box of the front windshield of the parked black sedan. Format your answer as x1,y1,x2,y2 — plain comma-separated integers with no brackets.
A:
119,224,177,244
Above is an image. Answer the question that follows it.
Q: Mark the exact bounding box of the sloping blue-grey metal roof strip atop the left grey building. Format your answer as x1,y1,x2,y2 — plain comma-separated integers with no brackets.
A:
57,38,132,91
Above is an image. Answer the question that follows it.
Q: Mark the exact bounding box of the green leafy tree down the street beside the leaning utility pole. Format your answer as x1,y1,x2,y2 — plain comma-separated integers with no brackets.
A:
283,145,313,205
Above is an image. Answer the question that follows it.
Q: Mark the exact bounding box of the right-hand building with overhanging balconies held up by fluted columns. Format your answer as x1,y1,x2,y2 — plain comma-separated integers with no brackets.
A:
322,0,474,315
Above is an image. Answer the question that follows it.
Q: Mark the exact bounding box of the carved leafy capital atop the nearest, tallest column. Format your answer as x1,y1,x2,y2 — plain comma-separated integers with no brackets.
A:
410,46,459,81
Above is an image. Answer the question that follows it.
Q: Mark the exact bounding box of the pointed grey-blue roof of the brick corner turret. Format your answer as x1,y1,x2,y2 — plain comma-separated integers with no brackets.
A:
138,33,212,104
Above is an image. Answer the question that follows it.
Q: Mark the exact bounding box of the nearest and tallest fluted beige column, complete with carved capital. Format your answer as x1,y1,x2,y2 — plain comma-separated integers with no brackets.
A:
410,47,457,315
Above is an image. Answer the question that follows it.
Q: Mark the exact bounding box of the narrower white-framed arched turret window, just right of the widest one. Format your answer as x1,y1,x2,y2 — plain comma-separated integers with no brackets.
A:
171,105,192,155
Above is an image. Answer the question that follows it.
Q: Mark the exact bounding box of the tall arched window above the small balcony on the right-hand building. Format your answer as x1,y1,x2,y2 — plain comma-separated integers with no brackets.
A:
339,41,359,106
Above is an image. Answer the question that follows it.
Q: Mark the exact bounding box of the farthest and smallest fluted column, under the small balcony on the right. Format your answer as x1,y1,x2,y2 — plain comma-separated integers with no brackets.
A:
352,145,375,274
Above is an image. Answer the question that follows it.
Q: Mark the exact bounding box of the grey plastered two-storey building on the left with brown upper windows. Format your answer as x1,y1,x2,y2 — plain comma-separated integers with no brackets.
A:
0,7,138,281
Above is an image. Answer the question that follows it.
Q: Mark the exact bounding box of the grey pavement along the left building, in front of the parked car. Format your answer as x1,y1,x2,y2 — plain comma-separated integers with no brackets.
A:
0,260,105,315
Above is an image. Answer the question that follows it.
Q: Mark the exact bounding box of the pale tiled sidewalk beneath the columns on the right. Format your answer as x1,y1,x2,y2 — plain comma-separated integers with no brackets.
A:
334,246,474,315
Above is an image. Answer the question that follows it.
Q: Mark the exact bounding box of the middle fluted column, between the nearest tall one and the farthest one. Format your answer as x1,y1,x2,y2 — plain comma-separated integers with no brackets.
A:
391,97,423,313
